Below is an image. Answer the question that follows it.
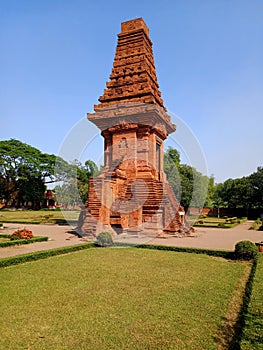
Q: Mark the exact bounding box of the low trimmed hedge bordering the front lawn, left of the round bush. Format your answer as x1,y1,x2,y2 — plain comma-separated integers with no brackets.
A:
0,242,94,268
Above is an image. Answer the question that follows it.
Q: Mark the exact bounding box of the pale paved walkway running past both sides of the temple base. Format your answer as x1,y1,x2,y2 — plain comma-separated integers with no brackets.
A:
0,221,263,258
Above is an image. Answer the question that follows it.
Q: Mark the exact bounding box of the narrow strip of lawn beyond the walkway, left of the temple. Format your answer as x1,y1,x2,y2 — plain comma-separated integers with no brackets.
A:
0,210,79,224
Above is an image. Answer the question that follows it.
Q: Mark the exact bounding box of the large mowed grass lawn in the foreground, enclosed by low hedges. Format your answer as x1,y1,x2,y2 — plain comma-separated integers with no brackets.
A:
0,248,247,350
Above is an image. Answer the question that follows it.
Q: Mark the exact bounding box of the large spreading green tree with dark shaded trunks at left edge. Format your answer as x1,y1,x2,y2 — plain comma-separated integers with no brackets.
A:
0,139,70,207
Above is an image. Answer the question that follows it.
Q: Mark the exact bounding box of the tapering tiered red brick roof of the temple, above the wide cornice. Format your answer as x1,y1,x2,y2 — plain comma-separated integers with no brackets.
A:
94,18,164,111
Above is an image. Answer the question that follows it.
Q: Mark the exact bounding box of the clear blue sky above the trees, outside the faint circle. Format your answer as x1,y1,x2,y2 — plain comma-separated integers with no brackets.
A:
0,0,263,182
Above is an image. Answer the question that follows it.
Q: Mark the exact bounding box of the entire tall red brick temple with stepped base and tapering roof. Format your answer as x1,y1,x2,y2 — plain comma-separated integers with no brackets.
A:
78,18,188,237
